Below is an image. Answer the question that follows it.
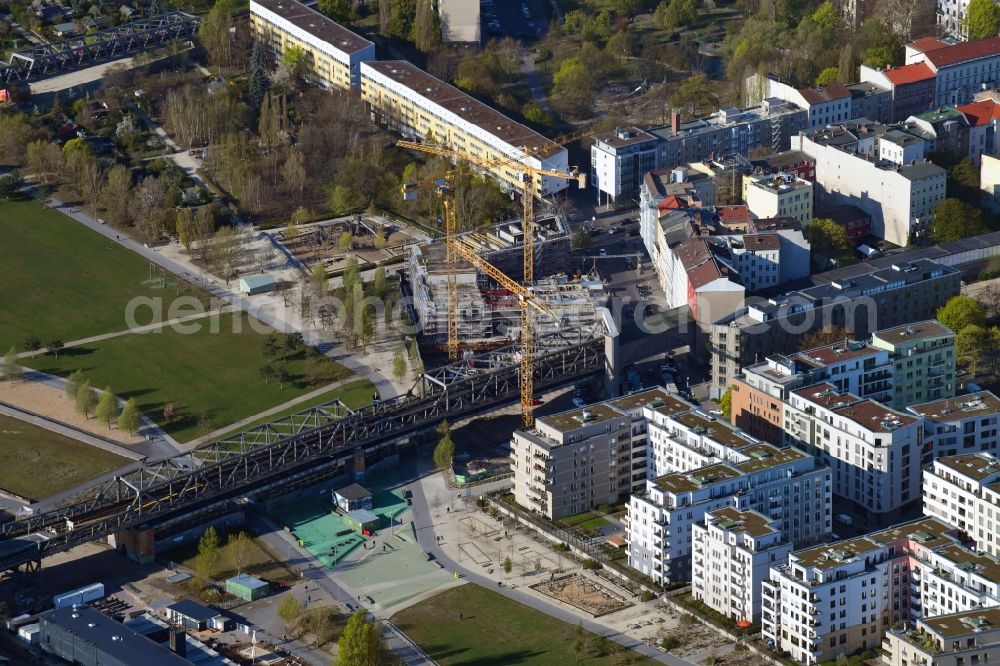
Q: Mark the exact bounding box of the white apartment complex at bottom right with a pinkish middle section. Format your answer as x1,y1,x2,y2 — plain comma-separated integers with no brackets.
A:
761,517,1000,666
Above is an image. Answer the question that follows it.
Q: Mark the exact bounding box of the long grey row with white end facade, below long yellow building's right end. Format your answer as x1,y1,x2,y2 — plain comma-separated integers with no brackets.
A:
590,98,806,204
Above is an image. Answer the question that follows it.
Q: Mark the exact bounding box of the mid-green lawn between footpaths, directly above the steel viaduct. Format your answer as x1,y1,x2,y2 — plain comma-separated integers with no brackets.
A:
26,314,350,441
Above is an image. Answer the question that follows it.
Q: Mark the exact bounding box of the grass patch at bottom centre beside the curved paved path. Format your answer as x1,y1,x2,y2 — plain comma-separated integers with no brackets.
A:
392,584,654,666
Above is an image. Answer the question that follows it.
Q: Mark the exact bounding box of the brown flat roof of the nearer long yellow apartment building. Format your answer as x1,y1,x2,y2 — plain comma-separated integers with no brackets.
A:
362,60,565,158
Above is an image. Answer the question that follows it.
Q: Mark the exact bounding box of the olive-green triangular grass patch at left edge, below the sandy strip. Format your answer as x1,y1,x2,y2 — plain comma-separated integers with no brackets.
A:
0,415,131,499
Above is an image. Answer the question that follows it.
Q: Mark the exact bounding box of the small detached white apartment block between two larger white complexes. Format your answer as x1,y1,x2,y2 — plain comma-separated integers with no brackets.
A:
691,507,792,623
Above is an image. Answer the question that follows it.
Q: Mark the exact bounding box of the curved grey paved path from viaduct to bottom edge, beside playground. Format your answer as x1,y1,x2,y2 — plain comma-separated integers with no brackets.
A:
407,456,693,666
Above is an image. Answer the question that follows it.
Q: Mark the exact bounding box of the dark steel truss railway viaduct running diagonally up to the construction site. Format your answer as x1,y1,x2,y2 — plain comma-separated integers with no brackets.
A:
0,338,607,572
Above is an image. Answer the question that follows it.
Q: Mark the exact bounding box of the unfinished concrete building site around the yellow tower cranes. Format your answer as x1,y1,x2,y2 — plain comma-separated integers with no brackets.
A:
407,216,607,351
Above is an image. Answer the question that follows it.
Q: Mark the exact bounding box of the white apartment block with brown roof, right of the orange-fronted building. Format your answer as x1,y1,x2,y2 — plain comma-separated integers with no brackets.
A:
783,380,923,525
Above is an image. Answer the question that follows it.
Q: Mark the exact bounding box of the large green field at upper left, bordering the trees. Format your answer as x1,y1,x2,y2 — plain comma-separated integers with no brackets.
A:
0,201,204,354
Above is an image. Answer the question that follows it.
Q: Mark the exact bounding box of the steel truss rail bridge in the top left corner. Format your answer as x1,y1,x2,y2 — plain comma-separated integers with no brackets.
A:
0,11,200,83
